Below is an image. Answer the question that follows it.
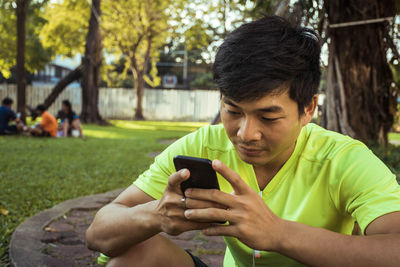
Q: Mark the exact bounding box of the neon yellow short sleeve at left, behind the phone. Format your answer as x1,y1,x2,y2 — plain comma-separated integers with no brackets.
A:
133,129,203,199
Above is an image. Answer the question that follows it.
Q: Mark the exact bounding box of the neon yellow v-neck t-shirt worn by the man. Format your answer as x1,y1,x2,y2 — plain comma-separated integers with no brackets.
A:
134,123,400,267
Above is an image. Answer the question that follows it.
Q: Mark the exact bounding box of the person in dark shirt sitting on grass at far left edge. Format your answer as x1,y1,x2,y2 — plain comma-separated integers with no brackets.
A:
0,97,24,135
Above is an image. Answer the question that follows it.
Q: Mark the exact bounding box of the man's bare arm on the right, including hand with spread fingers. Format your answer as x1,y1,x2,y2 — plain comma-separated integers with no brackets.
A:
185,161,400,266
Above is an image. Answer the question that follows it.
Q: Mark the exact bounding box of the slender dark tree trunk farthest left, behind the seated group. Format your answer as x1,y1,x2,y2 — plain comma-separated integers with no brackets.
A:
16,0,29,123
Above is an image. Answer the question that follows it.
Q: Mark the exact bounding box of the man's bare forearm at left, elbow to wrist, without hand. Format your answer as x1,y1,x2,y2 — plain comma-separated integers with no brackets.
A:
86,201,160,257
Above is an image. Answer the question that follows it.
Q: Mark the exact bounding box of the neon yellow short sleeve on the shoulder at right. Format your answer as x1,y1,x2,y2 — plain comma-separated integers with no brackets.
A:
333,144,400,233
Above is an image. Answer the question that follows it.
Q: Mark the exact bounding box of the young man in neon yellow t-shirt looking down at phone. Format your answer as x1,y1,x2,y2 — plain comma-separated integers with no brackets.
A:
86,16,400,266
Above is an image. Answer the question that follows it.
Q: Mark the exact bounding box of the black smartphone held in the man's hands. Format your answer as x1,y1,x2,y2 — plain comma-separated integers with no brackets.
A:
174,155,219,193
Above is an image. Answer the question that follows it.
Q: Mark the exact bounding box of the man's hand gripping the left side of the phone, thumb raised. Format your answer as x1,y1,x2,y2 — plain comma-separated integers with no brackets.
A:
156,169,221,235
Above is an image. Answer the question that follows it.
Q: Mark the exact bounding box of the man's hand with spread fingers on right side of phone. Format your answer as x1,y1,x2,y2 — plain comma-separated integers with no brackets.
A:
185,160,283,250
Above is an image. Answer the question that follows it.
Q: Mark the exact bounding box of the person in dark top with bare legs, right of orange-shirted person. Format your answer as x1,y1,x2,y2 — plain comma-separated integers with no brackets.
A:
56,100,83,137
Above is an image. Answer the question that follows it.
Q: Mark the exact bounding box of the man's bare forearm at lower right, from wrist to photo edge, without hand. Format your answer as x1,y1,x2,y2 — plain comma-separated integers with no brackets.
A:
276,221,400,266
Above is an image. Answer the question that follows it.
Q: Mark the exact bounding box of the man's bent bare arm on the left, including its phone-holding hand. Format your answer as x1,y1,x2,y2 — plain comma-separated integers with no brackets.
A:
86,170,212,257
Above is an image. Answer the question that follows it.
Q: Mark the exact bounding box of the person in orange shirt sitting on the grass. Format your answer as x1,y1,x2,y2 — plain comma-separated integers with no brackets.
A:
29,105,57,137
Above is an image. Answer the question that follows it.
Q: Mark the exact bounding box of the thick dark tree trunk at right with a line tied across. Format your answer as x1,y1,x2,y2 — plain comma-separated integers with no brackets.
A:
324,0,396,144
